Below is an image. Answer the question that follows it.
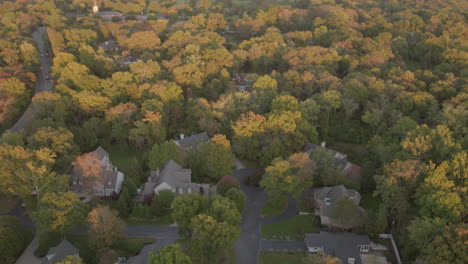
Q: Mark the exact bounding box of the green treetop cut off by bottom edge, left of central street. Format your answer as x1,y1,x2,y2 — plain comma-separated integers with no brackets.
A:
148,244,192,264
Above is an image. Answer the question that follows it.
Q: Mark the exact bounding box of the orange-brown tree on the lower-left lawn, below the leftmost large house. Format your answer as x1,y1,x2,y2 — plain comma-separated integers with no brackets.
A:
87,206,125,250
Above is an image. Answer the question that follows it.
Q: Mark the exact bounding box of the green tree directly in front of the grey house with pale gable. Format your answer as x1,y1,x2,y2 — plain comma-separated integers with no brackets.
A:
172,193,207,236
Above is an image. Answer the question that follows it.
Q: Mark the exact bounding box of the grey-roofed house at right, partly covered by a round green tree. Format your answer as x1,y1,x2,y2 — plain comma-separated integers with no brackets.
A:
313,185,364,227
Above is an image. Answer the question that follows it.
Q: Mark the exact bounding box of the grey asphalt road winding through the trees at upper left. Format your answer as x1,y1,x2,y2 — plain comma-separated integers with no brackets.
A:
8,27,53,132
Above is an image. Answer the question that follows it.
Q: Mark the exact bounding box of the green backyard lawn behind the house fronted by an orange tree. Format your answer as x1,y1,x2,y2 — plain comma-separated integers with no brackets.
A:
105,144,143,172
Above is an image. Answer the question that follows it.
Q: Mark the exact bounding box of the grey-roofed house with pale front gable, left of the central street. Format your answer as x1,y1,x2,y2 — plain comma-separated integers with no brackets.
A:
140,160,216,202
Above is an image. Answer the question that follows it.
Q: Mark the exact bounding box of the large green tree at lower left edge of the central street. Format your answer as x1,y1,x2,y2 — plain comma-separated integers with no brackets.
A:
190,214,240,263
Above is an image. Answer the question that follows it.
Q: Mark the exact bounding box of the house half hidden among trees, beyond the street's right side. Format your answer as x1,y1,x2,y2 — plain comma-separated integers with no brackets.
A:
303,142,361,180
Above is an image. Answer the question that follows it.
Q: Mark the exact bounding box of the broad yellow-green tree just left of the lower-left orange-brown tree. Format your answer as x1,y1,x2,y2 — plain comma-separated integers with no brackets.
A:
32,192,86,235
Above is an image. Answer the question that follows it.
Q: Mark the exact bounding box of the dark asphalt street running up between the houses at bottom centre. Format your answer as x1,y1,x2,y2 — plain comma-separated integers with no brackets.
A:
232,169,267,264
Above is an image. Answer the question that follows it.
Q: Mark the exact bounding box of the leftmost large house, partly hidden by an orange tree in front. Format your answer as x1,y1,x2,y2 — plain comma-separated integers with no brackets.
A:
72,147,124,197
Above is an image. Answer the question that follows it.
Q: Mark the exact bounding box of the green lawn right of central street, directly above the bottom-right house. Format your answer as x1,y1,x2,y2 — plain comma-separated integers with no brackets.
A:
262,215,319,240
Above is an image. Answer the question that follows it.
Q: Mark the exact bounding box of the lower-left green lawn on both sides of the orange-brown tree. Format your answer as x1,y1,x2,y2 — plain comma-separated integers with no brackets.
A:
66,234,156,264
